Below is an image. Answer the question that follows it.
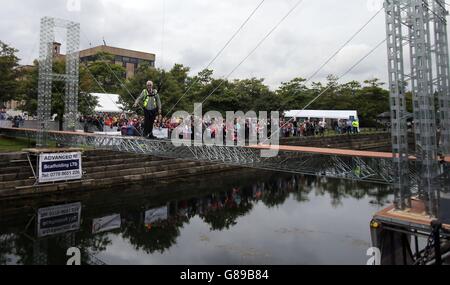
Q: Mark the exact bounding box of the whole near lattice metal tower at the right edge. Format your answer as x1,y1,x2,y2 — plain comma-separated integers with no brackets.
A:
385,0,450,213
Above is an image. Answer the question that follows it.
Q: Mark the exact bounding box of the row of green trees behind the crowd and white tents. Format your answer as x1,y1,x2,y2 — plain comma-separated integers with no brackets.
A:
0,39,390,127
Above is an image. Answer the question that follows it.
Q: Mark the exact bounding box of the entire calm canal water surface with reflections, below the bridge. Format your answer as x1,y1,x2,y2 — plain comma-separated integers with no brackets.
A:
0,171,393,265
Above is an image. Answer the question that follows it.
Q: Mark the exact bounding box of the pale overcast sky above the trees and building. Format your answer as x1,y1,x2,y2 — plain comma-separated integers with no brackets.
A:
0,0,418,87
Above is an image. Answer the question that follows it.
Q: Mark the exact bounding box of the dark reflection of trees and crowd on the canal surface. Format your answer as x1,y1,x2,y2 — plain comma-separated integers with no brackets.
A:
0,171,391,264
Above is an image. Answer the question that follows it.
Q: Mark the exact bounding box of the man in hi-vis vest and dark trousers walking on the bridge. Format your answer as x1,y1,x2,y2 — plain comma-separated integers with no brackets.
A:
134,81,162,139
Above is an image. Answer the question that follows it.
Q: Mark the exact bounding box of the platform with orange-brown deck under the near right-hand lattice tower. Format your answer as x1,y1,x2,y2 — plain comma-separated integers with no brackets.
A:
370,198,450,265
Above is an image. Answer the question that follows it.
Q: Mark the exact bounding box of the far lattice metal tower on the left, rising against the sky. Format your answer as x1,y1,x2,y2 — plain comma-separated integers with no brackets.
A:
37,17,80,146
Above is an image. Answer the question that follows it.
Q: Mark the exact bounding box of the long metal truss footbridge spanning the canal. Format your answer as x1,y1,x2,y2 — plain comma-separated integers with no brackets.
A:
0,128,450,184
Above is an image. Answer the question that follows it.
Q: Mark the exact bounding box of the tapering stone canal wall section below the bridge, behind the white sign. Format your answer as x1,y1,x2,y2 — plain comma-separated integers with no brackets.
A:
0,151,236,200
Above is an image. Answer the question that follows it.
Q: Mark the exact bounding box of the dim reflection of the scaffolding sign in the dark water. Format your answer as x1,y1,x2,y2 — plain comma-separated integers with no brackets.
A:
37,203,81,237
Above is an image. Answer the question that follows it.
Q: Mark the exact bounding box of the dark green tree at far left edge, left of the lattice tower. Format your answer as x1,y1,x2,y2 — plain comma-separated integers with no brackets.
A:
0,41,20,104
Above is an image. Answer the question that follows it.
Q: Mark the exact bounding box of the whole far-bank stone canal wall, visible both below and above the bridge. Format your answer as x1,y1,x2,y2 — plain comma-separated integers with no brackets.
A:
0,133,404,200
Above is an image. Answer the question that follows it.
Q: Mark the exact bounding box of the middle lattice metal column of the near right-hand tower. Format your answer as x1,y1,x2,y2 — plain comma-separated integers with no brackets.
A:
407,0,439,213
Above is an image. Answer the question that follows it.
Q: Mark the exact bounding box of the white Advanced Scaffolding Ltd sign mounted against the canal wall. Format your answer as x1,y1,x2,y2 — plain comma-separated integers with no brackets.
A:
39,152,83,183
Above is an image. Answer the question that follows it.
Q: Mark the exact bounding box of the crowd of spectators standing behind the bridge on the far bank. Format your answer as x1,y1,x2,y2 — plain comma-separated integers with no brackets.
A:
80,113,359,140
